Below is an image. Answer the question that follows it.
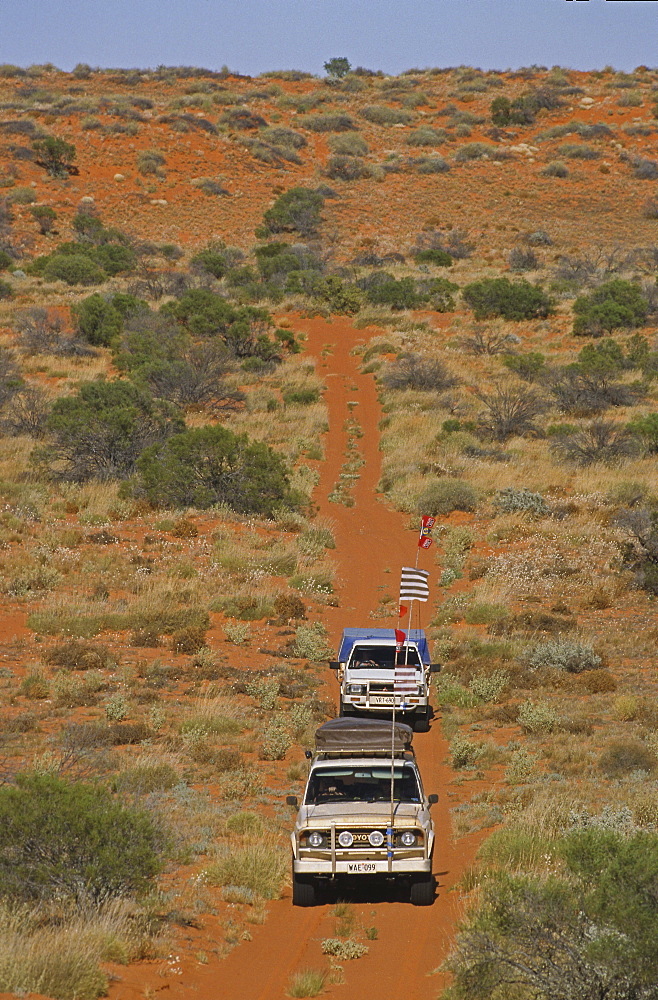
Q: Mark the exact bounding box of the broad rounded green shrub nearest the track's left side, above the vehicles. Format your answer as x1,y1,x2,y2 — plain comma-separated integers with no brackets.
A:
134,425,292,516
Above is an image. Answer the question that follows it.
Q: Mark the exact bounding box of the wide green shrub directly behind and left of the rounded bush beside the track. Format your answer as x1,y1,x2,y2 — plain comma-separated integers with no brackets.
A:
35,380,183,482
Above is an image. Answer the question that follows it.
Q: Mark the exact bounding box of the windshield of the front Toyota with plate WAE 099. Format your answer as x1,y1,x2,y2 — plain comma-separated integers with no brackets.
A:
305,764,420,805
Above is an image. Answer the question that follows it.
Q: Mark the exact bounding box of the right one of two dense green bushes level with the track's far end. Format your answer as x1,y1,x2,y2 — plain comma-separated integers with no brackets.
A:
573,278,649,337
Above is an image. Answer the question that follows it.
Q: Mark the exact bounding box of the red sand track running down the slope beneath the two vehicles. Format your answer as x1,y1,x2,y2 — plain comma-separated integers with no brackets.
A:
91,319,482,1000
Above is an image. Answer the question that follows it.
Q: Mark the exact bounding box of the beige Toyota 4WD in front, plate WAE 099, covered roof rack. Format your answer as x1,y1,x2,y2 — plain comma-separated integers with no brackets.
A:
286,718,438,906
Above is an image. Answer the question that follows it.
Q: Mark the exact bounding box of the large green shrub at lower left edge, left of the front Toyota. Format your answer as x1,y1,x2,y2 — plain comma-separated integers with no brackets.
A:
0,774,163,902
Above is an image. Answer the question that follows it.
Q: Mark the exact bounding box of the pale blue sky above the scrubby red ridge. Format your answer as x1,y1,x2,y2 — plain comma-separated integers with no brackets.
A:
0,0,658,76
